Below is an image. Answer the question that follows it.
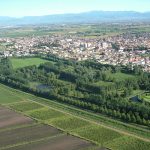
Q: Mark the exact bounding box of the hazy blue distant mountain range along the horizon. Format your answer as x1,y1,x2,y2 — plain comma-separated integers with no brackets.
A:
0,11,150,26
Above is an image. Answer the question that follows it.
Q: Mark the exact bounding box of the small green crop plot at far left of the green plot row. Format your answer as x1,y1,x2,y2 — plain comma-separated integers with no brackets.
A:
10,101,43,112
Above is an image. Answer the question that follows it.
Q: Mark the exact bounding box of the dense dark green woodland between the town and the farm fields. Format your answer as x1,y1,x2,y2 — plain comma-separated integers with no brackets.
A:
0,55,150,126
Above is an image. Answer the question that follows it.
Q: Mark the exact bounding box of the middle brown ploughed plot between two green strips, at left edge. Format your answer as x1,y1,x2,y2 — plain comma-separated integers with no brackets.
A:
0,125,60,148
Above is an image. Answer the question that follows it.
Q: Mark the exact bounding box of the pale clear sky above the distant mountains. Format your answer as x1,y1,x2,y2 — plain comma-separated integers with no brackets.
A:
0,0,150,17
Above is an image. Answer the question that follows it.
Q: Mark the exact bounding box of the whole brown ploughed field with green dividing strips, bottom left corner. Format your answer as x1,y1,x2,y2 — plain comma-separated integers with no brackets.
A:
0,106,96,150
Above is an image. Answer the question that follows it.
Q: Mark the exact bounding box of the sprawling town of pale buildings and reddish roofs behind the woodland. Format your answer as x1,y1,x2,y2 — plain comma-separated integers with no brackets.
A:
0,33,150,72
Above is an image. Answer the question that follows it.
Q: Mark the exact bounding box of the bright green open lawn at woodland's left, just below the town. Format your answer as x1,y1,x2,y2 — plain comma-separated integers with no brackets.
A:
11,58,49,69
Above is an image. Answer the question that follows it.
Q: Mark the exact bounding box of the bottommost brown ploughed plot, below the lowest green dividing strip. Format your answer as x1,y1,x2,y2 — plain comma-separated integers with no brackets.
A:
7,135,92,150
